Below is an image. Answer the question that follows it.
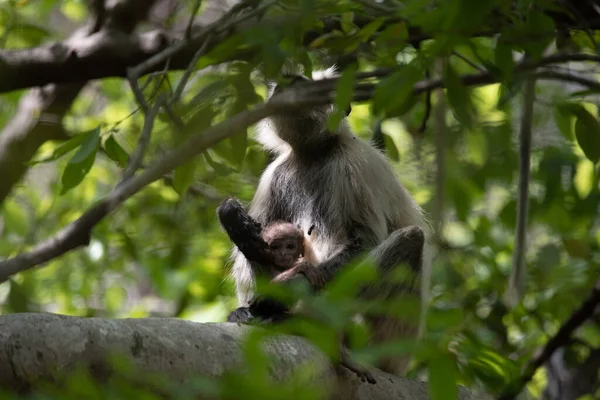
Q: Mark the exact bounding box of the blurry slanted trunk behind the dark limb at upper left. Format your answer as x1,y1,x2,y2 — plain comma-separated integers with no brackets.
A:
0,0,156,204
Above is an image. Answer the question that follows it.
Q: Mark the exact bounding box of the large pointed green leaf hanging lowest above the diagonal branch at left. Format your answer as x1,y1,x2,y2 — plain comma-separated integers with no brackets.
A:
60,127,100,195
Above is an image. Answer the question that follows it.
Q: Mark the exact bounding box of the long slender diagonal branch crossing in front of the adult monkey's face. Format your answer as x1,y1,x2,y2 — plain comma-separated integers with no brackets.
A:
0,63,600,282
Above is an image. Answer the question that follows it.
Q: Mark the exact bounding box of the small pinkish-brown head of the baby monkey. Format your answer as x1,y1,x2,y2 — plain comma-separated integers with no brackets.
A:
262,221,304,271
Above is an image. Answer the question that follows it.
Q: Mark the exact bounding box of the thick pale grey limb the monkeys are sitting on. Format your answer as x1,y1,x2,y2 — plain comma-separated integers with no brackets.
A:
0,313,472,400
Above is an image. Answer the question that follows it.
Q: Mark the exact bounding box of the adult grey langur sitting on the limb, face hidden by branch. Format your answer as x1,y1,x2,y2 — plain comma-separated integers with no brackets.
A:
221,68,431,375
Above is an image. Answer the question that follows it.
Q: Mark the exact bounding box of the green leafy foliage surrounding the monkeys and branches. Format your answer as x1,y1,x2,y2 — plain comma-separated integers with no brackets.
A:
0,0,600,399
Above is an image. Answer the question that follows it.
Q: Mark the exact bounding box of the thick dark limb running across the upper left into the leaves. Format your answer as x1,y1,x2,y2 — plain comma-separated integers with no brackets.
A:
0,1,600,93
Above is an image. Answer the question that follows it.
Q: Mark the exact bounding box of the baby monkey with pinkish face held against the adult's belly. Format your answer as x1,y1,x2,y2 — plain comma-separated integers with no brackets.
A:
261,220,317,278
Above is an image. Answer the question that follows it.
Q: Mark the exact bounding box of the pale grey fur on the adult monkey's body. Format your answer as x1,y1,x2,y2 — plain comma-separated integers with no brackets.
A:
232,69,431,374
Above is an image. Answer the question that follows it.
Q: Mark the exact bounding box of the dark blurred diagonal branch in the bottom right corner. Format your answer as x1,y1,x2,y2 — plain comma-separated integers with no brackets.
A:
498,281,600,400
